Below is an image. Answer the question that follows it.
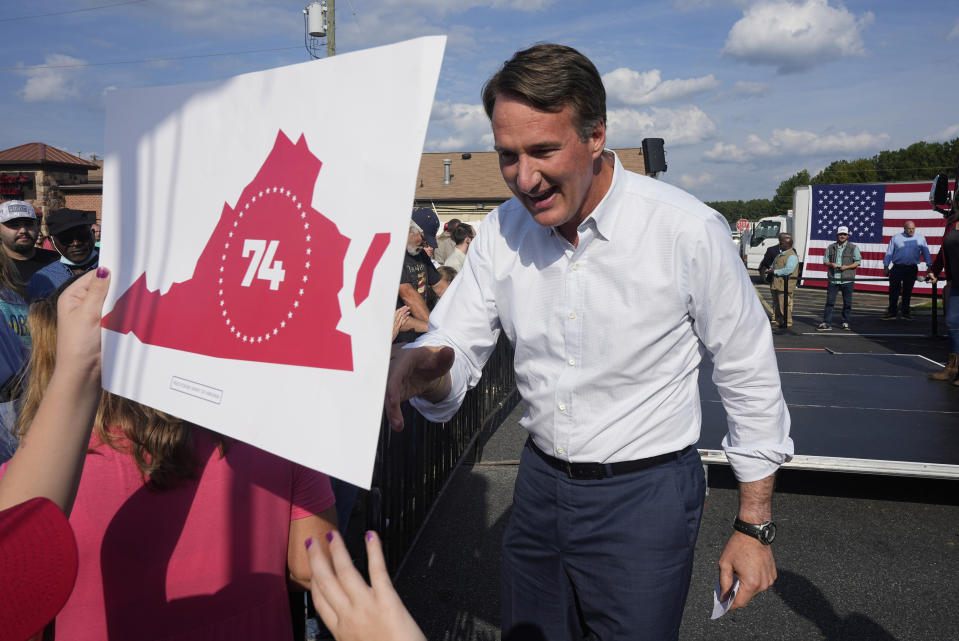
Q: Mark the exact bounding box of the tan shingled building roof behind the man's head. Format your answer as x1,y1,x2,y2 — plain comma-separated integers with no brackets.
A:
416,147,646,202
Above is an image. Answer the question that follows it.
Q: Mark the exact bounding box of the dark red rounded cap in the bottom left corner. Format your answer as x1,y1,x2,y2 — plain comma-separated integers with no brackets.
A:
0,497,77,641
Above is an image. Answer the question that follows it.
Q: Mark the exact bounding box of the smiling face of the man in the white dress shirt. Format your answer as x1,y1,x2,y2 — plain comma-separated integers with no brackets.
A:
492,95,606,234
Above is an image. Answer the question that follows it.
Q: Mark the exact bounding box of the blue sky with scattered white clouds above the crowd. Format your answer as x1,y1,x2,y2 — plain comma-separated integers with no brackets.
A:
0,0,959,200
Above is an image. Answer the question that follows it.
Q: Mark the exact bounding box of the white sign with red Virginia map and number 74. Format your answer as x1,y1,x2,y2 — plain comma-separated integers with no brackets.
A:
100,37,446,487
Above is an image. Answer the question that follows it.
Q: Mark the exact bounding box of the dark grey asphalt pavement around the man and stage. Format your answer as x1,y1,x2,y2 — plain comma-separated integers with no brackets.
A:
397,280,959,641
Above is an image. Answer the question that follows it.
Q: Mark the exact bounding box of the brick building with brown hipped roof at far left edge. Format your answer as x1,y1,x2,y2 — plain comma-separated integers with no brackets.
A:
0,142,103,221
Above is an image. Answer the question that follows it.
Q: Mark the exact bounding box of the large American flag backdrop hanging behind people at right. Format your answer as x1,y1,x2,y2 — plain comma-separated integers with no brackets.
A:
802,182,954,294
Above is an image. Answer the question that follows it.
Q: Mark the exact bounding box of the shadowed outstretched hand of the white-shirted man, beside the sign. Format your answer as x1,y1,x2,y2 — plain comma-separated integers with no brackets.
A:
384,347,454,432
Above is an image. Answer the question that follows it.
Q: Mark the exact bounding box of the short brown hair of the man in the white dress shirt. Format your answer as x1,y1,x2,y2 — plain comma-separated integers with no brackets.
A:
483,43,606,141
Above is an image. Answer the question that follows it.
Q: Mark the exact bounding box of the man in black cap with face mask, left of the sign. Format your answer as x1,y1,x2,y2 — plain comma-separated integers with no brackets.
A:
27,209,100,300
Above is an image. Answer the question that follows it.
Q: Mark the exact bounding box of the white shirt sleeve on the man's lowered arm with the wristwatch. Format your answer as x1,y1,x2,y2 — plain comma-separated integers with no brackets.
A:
684,214,793,482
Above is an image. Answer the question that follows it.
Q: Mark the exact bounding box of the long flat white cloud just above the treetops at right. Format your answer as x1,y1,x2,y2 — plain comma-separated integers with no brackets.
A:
703,129,889,163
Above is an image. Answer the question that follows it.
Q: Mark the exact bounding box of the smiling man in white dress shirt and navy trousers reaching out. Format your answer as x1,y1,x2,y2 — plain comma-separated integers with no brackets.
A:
386,44,793,641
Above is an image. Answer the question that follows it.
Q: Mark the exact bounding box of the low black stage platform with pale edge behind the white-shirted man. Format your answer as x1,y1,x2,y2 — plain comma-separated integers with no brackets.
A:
697,349,959,478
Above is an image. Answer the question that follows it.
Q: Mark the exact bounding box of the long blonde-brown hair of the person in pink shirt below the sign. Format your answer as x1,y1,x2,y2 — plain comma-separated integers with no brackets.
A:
16,287,227,490
